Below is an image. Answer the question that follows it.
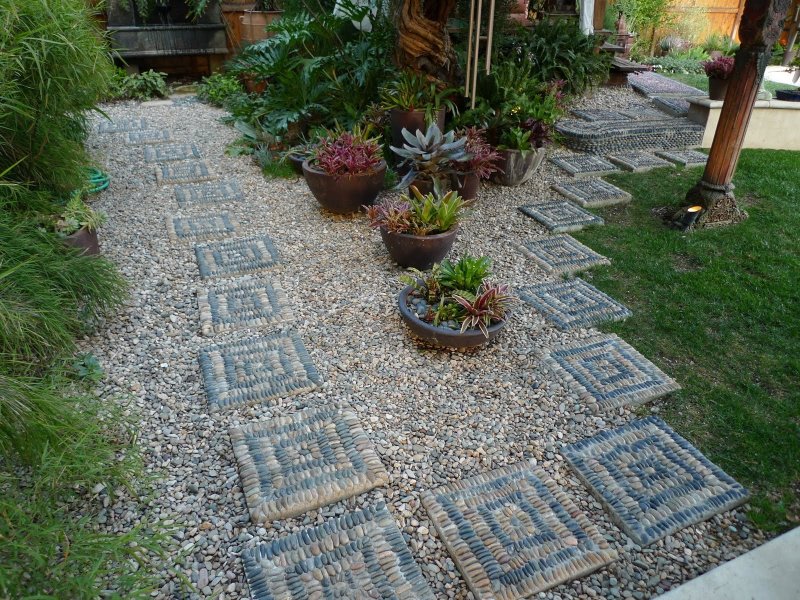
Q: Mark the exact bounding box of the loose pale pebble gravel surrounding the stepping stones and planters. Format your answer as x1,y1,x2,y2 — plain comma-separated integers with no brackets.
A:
84,90,764,599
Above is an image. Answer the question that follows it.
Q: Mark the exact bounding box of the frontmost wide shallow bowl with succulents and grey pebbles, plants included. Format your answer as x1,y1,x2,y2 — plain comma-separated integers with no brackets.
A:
397,255,516,348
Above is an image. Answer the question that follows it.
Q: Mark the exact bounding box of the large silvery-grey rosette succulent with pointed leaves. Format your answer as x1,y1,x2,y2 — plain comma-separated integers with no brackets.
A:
391,123,467,194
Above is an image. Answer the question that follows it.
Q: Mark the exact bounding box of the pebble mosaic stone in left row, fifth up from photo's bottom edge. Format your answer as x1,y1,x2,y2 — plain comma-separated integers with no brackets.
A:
194,235,278,278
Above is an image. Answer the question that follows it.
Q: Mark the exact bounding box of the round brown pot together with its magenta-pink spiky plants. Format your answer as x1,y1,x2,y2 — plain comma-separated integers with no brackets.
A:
303,131,386,214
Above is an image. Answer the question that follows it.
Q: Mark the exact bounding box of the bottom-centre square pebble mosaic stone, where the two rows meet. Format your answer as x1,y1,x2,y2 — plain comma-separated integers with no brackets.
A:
422,461,617,600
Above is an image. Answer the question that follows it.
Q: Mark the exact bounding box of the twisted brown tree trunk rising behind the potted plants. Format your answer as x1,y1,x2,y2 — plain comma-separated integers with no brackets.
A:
396,0,459,84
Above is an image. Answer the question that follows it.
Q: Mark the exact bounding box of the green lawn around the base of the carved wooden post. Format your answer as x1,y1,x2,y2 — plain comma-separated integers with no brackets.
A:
575,150,800,530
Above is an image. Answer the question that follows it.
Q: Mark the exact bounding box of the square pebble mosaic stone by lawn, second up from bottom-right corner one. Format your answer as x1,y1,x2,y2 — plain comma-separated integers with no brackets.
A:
544,335,680,411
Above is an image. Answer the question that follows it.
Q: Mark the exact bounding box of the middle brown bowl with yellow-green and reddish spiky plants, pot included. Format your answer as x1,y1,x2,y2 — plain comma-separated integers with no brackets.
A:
367,185,464,269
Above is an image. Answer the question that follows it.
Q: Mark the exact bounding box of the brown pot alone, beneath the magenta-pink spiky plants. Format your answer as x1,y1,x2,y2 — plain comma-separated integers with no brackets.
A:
303,160,386,215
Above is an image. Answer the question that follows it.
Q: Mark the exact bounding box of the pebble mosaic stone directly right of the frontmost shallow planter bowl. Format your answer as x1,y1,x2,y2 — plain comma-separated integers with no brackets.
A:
518,277,632,329
